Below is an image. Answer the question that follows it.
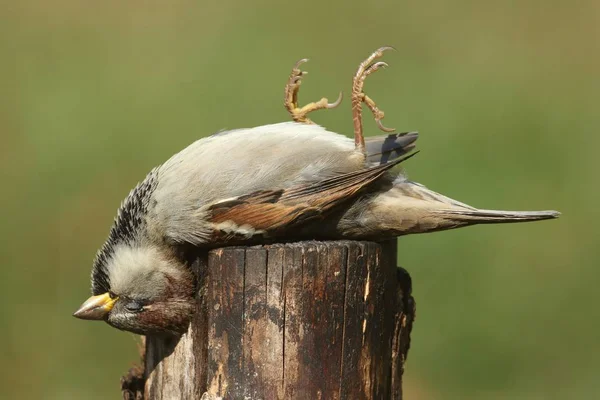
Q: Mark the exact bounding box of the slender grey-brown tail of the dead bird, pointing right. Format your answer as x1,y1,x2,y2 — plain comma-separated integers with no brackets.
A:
439,209,560,225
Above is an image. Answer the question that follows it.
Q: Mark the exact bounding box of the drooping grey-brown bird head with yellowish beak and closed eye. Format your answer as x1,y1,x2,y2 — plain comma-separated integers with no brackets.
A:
73,244,194,335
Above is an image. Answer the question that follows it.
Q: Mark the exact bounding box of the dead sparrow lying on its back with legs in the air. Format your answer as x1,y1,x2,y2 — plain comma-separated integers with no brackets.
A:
74,47,559,335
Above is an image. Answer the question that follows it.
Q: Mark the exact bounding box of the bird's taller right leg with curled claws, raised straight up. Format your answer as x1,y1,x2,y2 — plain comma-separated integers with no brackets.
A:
351,47,394,152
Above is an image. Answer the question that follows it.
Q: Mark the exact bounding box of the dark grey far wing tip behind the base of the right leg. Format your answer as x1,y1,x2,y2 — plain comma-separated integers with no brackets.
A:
365,132,419,165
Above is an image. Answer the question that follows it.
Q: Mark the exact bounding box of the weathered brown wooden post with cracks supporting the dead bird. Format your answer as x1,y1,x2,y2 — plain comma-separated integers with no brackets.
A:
123,240,415,400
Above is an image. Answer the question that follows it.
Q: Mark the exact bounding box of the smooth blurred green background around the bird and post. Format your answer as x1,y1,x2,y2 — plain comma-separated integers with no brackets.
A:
0,0,600,399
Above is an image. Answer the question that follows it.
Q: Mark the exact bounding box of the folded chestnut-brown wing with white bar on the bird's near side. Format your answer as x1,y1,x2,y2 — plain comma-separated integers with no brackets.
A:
208,152,416,238
